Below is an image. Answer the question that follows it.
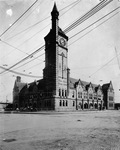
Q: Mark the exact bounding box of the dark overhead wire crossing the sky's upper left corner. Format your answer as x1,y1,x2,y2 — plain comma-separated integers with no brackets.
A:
0,0,38,37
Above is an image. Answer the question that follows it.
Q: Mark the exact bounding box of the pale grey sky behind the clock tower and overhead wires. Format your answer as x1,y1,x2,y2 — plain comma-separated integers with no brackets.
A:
0,0,120,102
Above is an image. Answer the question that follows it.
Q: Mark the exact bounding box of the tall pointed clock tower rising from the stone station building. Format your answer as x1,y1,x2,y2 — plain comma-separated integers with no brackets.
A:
43,3,68,105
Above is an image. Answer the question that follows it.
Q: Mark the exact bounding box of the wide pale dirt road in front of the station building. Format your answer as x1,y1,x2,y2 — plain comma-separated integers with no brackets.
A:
0,110,120,150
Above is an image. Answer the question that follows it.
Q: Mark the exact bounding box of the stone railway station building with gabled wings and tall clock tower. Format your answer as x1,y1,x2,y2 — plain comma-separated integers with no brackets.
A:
13,4,114,111
